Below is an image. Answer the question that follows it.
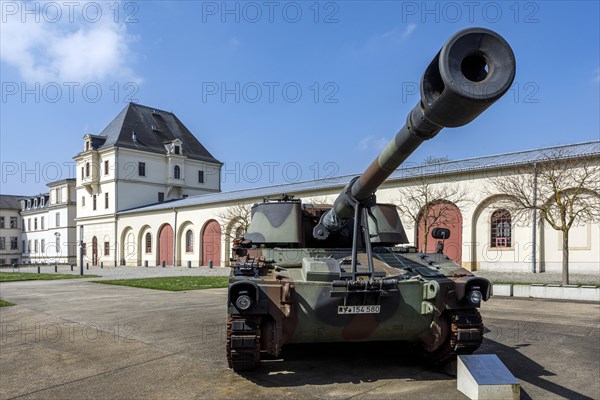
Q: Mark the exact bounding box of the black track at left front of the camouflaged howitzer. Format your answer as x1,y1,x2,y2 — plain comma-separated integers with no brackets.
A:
227,315,260,372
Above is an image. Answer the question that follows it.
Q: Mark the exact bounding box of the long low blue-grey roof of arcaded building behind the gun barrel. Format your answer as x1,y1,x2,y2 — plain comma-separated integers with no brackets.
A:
119,141,600,214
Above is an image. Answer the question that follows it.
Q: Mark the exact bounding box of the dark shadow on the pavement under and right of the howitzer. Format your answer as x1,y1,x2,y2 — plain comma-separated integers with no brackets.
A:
242,339,592,399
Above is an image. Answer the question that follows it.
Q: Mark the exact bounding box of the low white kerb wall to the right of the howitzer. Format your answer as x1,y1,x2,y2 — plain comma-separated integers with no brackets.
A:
492,283,600,302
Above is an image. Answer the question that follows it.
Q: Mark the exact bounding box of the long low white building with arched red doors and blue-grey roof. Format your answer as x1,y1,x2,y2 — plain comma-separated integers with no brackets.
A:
116,142,600,274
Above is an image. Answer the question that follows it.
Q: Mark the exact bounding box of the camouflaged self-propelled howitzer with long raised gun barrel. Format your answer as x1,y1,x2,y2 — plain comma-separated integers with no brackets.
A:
227,28,515,371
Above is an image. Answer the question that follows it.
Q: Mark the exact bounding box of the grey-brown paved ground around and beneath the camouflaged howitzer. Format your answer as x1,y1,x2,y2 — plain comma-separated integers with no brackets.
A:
0,278,600,399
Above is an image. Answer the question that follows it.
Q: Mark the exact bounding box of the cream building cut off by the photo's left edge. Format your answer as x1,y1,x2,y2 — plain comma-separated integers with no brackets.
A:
0,194,22,266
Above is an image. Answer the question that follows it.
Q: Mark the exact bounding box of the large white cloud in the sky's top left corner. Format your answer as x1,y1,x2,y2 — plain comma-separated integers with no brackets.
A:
0,2,140,82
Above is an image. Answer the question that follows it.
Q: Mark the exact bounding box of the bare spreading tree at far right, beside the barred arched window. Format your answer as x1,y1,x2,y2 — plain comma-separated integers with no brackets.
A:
488,148,600,285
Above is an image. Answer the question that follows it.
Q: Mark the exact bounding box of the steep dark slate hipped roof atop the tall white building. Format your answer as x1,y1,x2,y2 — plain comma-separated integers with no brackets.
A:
85,103,220,164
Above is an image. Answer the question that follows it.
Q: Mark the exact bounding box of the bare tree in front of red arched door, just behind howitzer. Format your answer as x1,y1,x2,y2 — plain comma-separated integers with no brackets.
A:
394,177,471,253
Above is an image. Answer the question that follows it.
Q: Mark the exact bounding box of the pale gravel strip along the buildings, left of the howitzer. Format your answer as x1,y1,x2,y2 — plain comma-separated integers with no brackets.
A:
0,265,230,279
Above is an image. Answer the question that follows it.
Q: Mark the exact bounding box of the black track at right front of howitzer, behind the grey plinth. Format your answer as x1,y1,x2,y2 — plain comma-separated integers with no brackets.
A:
425,309,483,365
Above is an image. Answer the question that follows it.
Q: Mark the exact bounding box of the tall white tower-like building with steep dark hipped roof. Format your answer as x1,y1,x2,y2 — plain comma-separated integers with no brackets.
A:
74,103,221,265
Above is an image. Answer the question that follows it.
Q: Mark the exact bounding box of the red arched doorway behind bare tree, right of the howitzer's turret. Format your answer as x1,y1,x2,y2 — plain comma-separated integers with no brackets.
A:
417,201,462,264
